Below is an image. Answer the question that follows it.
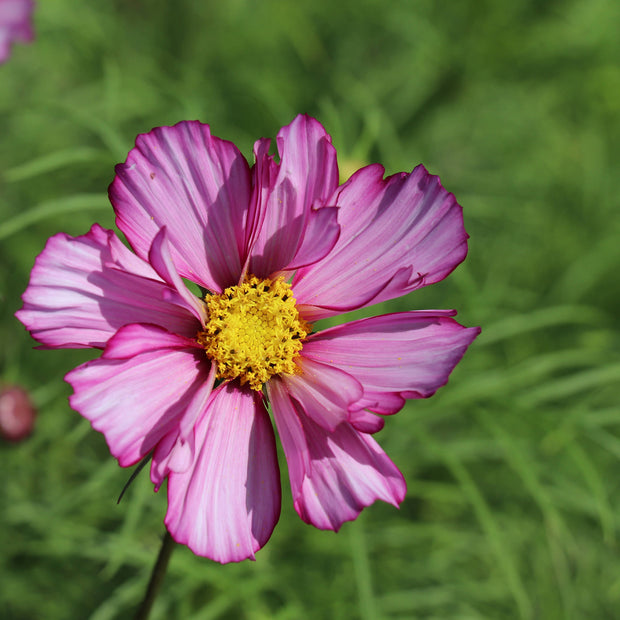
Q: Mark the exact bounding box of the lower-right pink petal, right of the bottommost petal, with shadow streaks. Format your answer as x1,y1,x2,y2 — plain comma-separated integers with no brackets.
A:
268,382,406,531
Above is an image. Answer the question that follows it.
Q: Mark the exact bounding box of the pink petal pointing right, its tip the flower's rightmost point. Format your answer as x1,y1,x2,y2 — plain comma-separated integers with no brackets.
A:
303,310,480,413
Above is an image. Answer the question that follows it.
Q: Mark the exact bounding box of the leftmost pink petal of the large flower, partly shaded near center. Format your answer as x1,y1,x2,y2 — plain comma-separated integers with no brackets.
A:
16,224,200,348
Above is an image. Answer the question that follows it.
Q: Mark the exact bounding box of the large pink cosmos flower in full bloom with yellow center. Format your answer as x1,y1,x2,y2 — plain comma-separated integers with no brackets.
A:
17,116,479,563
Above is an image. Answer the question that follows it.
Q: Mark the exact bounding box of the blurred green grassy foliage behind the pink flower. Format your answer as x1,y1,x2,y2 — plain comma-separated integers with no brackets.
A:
0,0,620,620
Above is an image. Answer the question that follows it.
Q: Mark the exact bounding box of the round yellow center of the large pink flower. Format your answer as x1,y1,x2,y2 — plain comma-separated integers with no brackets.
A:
198,276,311,390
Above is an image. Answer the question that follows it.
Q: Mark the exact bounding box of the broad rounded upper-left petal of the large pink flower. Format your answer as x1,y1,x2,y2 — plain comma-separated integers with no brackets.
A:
109,121,251,292
